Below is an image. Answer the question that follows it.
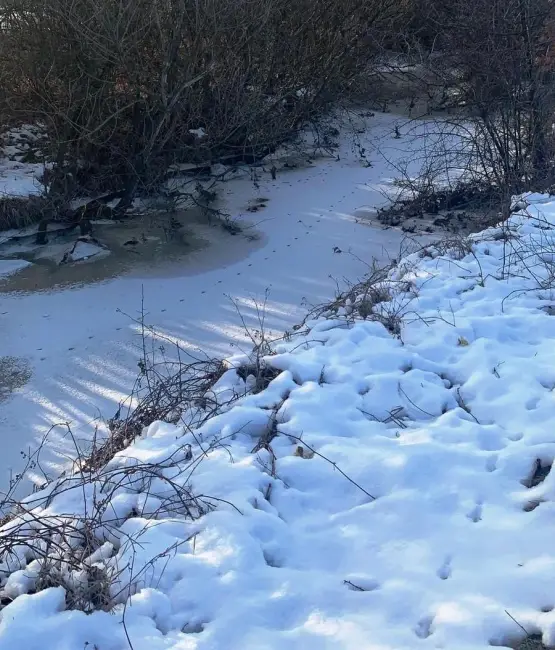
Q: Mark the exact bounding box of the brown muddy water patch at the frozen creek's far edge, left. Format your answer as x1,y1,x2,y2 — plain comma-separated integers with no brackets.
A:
0,209,262,293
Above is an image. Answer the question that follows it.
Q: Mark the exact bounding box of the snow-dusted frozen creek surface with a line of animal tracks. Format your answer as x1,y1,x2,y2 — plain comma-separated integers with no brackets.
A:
0,111,434,488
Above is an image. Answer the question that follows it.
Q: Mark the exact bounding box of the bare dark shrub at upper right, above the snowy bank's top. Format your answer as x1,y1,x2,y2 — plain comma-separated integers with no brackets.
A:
398,0,555,218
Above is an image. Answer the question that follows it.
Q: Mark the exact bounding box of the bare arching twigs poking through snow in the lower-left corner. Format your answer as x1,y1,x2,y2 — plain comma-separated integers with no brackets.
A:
0,432,219,612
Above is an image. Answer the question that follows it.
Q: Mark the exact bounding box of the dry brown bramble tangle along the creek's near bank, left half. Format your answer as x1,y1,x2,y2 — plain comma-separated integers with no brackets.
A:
0,292,286,613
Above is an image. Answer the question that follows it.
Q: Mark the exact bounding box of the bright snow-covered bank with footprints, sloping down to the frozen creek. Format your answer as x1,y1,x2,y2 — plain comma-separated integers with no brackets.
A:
0,196,555,650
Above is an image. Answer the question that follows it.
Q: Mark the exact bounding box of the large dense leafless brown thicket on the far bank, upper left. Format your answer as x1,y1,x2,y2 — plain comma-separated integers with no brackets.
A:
0,0,404,209
